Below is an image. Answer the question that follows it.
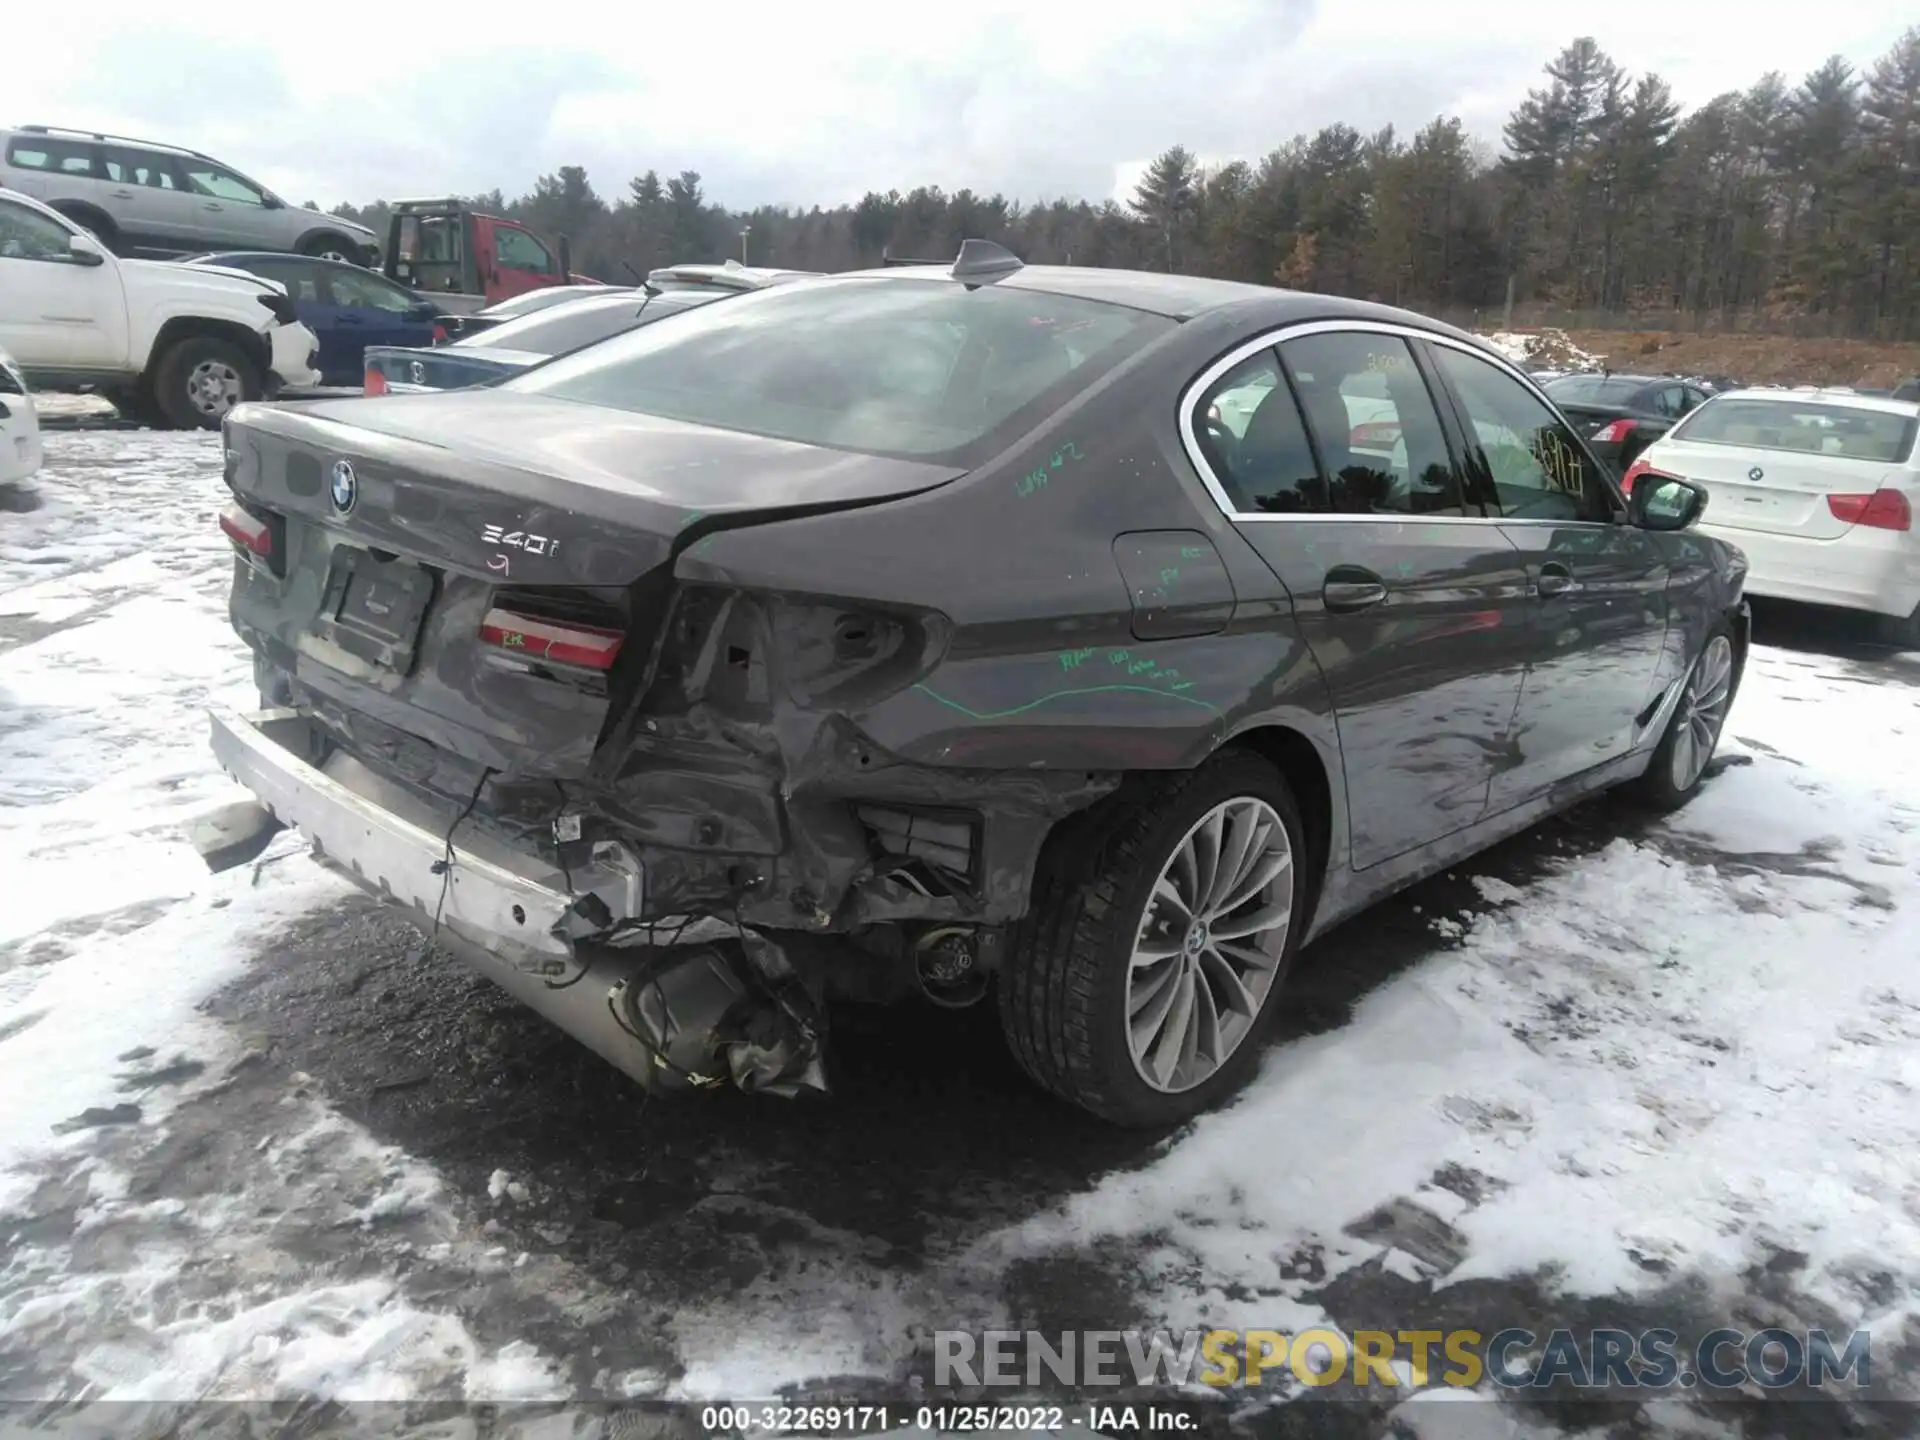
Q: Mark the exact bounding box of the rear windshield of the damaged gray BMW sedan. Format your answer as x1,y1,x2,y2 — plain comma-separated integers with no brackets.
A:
507,278,1175,467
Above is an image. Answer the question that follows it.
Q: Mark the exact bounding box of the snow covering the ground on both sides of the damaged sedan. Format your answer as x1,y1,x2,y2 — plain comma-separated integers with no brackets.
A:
0,432,1920,1434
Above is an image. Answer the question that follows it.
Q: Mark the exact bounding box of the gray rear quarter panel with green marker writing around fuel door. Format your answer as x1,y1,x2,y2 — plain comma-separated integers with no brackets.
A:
676,301,1340,802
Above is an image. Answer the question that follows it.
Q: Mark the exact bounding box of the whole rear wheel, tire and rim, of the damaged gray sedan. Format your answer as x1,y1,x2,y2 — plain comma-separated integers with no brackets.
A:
1000,753,1308,1127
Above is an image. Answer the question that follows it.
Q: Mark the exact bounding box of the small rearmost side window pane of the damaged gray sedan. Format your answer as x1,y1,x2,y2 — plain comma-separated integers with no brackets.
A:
1194,349,1327,515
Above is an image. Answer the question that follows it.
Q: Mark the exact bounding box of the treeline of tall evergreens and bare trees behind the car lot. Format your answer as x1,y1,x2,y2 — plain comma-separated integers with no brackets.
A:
322,27,1920,340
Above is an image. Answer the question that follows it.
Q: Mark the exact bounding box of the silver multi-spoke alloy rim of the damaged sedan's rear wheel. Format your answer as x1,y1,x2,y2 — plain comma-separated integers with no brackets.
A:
1127,795,1294,1094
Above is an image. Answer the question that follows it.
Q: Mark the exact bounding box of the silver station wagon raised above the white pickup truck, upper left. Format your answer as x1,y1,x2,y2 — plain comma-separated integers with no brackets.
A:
0,125,380,265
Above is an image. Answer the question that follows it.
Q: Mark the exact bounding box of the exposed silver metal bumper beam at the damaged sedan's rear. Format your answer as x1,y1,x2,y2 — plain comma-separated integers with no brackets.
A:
209,708,641,972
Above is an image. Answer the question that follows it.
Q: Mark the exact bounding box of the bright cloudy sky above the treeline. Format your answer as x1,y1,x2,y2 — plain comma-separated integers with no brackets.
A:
15,0,1914,205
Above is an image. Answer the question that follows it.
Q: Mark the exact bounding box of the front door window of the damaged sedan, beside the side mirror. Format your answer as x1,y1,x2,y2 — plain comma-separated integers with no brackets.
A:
1434,346,1613,520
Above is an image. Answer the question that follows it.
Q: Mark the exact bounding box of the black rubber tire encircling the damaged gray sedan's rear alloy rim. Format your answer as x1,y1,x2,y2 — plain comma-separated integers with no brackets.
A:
998,751,1311,1127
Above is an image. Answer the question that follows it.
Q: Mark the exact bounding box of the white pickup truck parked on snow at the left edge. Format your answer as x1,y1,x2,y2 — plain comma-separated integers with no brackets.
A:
0,190,321,430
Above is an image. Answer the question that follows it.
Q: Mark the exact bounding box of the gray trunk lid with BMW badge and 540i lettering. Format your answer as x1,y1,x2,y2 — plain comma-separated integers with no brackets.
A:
227,390,960,791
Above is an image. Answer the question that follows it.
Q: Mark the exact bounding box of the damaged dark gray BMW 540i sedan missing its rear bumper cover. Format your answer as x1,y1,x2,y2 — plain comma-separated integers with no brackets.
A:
202,240,1749,1125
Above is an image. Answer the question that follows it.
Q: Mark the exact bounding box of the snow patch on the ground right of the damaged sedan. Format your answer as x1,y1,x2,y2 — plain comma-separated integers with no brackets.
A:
987,649,1920,1413
